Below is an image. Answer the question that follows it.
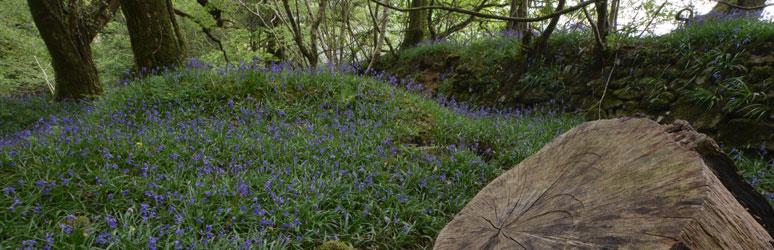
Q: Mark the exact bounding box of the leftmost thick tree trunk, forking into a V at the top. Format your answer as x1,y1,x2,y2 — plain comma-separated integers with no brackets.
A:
27,0,118,100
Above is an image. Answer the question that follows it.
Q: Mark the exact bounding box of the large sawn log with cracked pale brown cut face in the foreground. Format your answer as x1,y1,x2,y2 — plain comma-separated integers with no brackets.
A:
435,118,774,249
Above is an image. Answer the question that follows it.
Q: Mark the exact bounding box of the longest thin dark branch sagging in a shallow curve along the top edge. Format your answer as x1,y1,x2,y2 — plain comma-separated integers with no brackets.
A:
371,0,598,22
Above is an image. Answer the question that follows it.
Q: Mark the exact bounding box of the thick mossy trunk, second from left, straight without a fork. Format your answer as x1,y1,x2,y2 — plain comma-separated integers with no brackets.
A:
121,0,186,72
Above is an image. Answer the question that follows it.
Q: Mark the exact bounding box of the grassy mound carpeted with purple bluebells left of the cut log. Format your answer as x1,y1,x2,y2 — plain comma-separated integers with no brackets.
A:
0,63,581,249
